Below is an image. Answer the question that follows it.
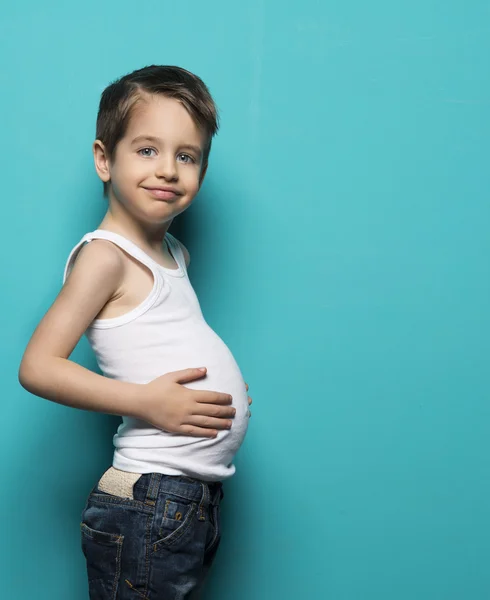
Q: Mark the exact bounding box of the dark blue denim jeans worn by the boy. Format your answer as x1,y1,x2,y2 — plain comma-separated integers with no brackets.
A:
80,473,223,600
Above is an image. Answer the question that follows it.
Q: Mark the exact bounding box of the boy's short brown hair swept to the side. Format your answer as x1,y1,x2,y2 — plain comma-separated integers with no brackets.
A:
95,65,219,196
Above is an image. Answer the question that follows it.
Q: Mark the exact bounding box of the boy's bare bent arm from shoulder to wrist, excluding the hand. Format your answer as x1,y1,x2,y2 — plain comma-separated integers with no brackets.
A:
19,240,141,417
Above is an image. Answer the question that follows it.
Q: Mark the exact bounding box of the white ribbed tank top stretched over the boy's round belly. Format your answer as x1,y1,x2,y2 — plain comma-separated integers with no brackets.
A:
63,229,249,481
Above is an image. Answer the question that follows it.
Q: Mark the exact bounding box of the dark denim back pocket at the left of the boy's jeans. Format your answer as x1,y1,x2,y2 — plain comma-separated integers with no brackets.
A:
80,521,124,600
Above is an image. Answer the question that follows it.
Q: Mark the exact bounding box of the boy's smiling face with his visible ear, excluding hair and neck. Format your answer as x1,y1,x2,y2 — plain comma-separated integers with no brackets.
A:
94,95,206,225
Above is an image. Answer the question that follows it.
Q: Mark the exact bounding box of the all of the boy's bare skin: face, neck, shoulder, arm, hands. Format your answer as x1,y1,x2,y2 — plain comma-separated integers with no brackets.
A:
19,97,252,437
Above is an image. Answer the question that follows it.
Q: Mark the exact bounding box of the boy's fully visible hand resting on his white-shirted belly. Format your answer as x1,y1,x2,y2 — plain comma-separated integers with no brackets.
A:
136,369,237,438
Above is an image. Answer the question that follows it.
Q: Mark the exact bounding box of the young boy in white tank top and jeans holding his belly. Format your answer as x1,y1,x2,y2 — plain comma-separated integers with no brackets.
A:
19,66,251,600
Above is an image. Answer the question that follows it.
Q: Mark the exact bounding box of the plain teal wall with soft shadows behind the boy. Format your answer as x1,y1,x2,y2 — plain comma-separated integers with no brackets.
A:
0,0,490,600
